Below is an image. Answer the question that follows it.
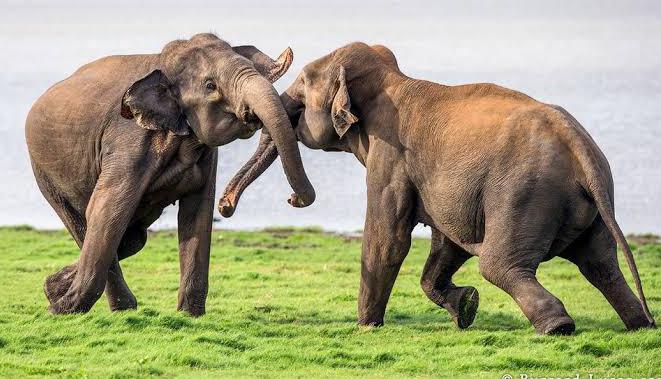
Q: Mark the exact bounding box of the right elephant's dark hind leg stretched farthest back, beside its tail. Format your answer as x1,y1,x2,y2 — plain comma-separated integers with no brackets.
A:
563,216,654,330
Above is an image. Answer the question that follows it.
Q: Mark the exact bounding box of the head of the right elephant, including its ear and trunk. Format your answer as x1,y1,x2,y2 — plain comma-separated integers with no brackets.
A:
218,43,394,217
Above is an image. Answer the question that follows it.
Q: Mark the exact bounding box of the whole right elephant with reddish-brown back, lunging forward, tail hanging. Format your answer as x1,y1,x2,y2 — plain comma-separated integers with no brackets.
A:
219,43,655,334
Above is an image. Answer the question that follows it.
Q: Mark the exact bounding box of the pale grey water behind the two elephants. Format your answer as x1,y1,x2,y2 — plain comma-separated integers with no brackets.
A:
0,0,661,233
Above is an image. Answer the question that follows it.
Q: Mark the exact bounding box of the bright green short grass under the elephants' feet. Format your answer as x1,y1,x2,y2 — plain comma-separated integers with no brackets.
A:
0,227,661,378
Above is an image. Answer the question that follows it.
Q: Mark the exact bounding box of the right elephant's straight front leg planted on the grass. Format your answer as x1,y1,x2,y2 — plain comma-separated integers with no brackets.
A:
358,163,414,326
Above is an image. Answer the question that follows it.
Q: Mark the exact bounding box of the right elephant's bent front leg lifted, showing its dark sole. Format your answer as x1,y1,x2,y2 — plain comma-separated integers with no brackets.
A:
420,229,479,329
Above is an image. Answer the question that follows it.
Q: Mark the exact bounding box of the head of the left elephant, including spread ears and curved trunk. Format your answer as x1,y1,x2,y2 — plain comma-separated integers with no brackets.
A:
121,34,315,206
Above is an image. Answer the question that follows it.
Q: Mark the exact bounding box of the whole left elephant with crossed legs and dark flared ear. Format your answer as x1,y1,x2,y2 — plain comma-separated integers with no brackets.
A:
26,34,315,316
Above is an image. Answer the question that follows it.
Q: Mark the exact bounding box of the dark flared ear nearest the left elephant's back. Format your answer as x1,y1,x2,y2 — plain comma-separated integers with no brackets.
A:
121,70,189,136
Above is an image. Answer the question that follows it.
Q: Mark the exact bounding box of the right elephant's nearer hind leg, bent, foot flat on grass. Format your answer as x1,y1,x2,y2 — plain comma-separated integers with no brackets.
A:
478,199,575,334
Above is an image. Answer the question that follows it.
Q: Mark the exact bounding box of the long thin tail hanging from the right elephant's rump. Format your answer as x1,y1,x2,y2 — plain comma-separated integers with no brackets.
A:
556,107,655,325
